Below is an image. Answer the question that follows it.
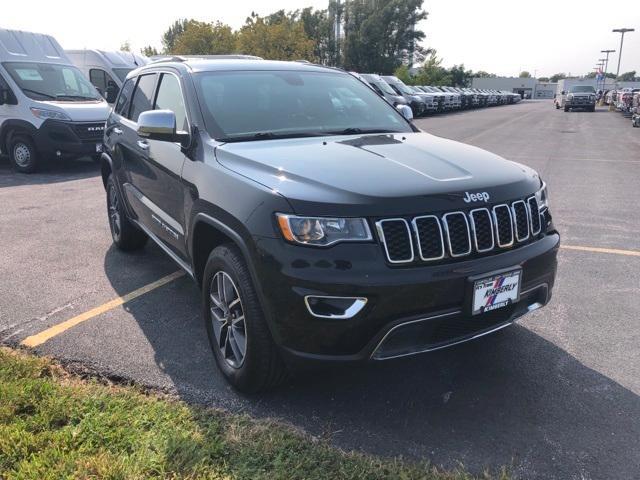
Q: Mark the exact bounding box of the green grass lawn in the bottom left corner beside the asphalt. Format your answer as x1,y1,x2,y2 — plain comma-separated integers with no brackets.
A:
0,348,506,480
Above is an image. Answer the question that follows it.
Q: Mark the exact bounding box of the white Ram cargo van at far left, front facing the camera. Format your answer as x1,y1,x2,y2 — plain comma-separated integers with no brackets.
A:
0,29,110,173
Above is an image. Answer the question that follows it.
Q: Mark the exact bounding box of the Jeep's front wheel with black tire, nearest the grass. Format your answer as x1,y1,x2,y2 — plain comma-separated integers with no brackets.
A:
202,244,287,393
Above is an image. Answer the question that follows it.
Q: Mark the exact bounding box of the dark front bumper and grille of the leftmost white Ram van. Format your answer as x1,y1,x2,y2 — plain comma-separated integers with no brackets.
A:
34,119,104,156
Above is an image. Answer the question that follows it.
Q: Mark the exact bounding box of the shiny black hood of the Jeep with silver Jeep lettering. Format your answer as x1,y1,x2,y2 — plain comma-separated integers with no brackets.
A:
215,132,540,216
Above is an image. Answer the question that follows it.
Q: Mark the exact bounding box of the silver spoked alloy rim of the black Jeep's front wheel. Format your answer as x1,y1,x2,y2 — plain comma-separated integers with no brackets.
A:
209,271,247,368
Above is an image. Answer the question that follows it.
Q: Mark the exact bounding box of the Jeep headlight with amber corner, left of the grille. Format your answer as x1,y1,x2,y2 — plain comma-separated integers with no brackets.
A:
276,213,373,247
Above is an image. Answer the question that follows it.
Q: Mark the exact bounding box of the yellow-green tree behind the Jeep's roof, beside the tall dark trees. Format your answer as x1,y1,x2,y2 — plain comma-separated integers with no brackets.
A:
238,11,314,60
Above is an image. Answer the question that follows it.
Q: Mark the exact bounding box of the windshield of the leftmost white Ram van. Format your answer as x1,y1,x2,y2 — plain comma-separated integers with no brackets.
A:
3,62,102,102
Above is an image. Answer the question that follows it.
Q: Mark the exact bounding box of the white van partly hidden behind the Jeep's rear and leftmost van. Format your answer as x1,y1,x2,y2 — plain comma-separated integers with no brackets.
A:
65,50,149,104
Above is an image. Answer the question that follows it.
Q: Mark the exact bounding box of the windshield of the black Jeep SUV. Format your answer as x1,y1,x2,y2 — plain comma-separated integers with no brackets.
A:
194,71,413,141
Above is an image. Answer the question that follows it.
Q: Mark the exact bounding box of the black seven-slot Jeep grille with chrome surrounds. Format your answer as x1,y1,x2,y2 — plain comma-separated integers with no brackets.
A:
376,197,548,264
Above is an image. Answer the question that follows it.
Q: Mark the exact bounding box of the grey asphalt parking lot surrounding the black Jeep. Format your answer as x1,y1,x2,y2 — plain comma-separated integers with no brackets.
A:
0,101,640,480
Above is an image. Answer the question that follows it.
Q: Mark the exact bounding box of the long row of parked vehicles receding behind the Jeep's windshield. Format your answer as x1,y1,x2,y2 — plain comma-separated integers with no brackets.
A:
351,72,522,117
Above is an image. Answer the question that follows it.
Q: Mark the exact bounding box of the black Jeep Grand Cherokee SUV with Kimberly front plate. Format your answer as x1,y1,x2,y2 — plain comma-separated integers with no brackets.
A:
102,58,559,391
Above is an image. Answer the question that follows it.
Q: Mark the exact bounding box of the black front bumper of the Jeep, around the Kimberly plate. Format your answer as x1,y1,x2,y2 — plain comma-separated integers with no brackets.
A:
255,233,560,361
